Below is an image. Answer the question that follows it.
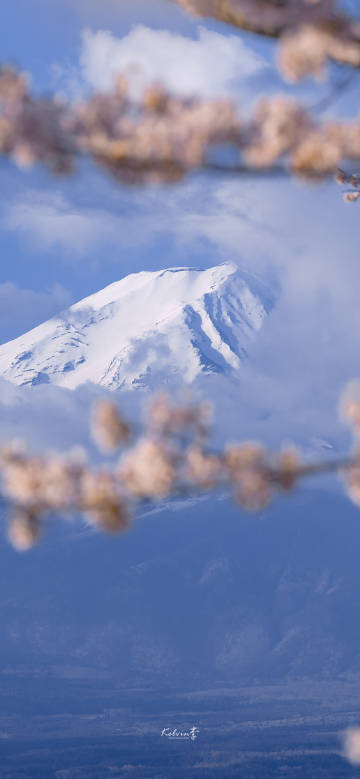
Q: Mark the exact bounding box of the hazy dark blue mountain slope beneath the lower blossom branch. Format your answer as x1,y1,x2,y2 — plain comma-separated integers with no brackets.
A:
0,489,360,684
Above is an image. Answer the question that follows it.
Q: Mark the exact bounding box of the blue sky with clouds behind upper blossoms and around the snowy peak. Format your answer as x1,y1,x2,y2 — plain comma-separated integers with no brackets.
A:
0,0,360,458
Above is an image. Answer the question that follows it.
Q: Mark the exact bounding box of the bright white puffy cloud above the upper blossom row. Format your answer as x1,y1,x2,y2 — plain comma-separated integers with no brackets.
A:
55,25,267,97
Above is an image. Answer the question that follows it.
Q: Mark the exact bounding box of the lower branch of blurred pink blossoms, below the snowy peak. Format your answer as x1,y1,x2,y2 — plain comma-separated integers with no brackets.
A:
0,385,360,550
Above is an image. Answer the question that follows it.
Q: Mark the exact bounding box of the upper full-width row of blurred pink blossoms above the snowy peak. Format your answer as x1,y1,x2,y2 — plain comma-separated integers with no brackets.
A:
0,68,360,183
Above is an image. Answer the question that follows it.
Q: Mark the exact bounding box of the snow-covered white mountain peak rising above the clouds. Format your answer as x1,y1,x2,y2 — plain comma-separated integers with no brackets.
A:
0,263,272,389
